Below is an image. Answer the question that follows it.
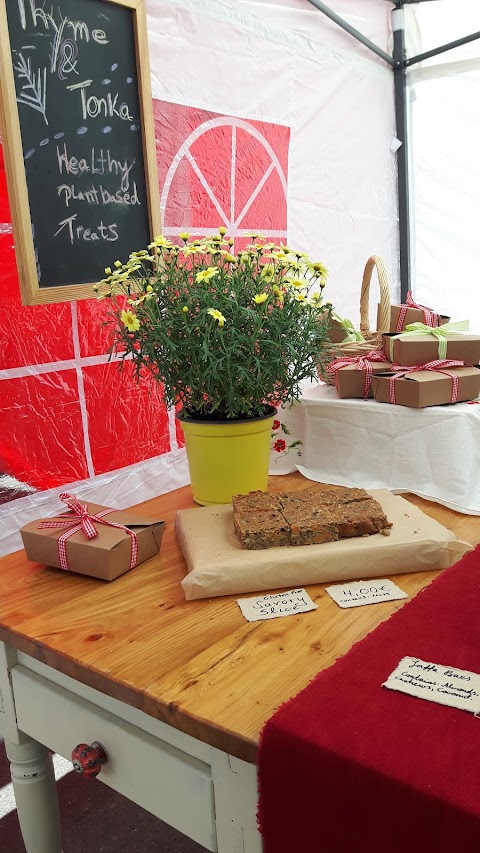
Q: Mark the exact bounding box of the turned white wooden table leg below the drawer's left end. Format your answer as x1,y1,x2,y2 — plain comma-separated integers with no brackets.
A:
5,740,61,853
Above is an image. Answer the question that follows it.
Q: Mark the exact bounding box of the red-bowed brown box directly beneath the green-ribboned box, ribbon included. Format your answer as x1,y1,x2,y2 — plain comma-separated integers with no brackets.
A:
372,360,480,409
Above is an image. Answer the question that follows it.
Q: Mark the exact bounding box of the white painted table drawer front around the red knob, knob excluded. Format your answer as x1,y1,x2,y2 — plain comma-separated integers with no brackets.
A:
11,666,217,851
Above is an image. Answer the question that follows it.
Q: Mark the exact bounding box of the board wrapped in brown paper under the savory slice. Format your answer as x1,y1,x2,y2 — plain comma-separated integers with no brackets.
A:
175,489,472,600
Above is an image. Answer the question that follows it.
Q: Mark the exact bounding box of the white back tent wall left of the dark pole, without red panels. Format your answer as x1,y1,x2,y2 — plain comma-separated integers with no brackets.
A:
0,0,399,553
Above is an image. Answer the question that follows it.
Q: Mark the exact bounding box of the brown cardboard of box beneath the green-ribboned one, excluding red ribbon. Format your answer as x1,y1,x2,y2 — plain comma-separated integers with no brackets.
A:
372,367,480,409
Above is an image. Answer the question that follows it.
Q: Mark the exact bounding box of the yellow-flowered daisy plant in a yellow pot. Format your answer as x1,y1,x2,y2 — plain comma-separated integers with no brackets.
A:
97,228,331,504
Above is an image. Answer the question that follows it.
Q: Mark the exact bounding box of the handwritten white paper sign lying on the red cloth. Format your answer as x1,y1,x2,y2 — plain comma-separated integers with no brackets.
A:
382,657,480,714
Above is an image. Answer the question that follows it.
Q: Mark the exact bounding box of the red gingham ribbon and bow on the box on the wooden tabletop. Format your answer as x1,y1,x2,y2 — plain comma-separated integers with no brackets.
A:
38,492,138,570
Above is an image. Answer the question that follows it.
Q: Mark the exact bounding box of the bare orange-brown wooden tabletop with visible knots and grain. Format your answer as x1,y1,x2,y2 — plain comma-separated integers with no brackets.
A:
0,473,480,762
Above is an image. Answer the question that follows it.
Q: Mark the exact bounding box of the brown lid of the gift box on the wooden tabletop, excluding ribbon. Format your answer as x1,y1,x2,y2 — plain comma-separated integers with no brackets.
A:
20,501,164,551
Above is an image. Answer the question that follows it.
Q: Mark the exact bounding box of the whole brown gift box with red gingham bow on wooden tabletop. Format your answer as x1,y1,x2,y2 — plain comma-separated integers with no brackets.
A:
20,494,165,581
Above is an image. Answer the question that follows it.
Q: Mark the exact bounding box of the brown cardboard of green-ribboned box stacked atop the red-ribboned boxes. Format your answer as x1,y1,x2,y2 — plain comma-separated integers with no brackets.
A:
383,332,480,367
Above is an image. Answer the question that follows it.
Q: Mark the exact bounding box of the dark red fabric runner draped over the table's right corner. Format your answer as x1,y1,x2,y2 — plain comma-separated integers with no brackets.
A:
258,546,480,853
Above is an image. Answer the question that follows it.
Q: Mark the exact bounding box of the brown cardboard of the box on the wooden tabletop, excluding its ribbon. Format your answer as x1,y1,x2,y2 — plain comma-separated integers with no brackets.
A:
20,501,165,581
